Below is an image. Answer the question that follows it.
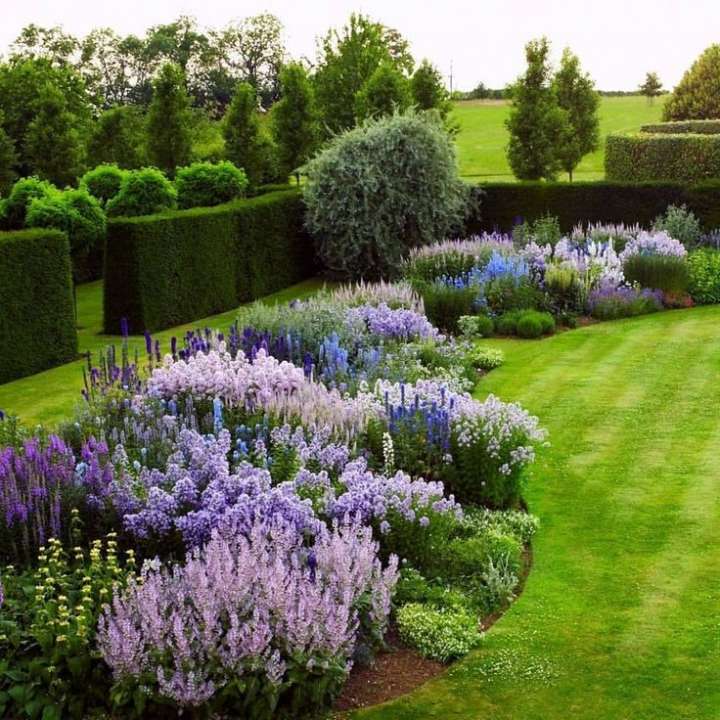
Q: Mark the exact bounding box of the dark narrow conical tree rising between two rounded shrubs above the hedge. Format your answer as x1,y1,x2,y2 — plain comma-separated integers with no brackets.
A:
147,63,192,177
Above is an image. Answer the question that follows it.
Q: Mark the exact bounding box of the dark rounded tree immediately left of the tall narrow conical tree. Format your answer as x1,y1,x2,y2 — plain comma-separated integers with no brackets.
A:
88,105,146,170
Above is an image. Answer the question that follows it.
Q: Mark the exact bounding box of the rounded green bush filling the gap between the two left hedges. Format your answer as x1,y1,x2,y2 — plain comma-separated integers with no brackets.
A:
26,189,106,282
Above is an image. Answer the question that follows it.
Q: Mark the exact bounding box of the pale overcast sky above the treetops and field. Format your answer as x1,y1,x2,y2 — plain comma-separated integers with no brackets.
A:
0,0,720,90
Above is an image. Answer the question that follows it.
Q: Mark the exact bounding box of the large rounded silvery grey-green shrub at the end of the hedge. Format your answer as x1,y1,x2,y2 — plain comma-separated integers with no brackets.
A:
304,113,469,279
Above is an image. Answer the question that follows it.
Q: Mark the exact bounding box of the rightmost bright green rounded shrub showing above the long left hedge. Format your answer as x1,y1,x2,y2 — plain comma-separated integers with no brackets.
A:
175,160,248,208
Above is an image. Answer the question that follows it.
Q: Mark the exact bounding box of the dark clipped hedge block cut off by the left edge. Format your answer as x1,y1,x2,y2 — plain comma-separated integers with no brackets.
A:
0,229,78,383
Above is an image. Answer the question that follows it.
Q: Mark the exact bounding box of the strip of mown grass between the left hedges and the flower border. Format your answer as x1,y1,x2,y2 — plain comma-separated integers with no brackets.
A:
0,279,322,425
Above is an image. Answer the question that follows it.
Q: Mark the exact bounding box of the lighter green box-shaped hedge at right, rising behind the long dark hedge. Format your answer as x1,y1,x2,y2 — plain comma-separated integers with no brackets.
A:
605,133,720,183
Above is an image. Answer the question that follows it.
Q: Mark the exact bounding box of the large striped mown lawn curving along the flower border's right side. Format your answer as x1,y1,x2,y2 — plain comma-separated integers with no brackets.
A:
356,307,720,720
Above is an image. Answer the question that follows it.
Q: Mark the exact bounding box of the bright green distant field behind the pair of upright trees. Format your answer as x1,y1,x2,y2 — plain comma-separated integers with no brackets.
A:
455,95,664,182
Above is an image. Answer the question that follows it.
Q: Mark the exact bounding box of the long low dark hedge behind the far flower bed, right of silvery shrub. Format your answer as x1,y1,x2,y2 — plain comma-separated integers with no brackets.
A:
467,181,720,233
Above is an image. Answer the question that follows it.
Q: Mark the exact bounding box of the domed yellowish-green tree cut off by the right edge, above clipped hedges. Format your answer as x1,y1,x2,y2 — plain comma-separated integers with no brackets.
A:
663,45,720,120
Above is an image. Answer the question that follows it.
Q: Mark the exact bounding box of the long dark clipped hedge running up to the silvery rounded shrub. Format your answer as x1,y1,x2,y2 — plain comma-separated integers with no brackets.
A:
104,190,316,334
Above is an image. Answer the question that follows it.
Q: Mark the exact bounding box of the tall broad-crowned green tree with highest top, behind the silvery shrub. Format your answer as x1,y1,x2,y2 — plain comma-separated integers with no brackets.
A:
314,13,413,133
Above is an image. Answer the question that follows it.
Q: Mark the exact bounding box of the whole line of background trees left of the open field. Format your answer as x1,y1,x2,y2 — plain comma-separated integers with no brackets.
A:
0,13,450,194
